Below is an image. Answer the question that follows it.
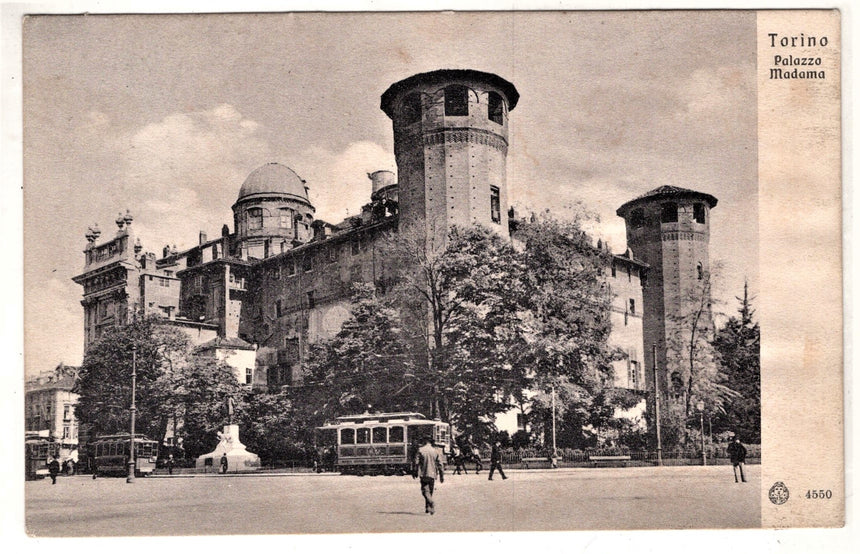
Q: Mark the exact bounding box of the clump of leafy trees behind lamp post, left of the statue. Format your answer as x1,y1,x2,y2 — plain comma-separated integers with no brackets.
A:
75,318,249,456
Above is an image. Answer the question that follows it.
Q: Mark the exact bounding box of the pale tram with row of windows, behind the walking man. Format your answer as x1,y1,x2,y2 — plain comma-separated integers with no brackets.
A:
316,412,451,475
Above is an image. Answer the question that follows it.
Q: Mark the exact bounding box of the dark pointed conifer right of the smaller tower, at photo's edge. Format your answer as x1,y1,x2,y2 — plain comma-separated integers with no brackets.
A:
714,283,761,443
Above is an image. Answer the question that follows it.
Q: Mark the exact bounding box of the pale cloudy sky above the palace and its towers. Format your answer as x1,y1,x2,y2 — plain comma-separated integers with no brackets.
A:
23,11,758,374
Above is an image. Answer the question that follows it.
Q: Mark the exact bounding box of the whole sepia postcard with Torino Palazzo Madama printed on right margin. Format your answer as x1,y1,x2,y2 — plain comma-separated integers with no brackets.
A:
13,4,845,539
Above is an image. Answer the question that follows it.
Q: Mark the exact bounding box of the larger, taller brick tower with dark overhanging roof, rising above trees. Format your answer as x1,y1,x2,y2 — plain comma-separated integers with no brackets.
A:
381,69,519,239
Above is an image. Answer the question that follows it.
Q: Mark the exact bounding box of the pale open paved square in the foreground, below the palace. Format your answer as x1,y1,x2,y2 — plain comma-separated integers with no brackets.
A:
25,466,761,537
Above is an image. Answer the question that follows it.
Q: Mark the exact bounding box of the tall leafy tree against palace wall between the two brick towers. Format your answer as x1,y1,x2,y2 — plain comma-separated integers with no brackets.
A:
516,213,639,447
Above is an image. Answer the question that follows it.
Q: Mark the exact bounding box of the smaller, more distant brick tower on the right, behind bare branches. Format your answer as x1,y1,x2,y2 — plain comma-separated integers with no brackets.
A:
616,186,717,408
